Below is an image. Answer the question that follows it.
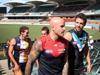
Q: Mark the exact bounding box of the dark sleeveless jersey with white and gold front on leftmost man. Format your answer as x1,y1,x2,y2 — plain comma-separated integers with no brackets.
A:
14,37,31,63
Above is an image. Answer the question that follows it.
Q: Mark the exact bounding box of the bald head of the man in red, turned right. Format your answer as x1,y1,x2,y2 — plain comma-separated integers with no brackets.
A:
50,17,65,36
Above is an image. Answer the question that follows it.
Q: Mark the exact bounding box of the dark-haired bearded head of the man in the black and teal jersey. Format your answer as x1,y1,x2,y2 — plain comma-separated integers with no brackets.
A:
75,13,87,31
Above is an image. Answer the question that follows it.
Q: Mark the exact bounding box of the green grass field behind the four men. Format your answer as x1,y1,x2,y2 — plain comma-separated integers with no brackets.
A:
0,24,100,43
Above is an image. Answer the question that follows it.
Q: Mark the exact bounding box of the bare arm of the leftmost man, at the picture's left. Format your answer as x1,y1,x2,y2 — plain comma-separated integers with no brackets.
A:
8,38,19,70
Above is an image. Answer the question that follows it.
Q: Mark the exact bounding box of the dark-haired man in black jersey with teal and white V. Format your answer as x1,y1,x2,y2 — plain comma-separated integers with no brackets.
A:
64,13,92,75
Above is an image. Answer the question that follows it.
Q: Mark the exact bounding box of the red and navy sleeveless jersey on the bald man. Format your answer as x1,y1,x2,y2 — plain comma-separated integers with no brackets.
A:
38,35,68,75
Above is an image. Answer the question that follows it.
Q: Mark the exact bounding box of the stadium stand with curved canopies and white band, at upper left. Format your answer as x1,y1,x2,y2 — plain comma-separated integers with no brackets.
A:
5,1,57,19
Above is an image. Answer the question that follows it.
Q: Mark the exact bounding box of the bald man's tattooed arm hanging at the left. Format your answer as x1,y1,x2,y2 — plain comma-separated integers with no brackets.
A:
25,40,42,75
